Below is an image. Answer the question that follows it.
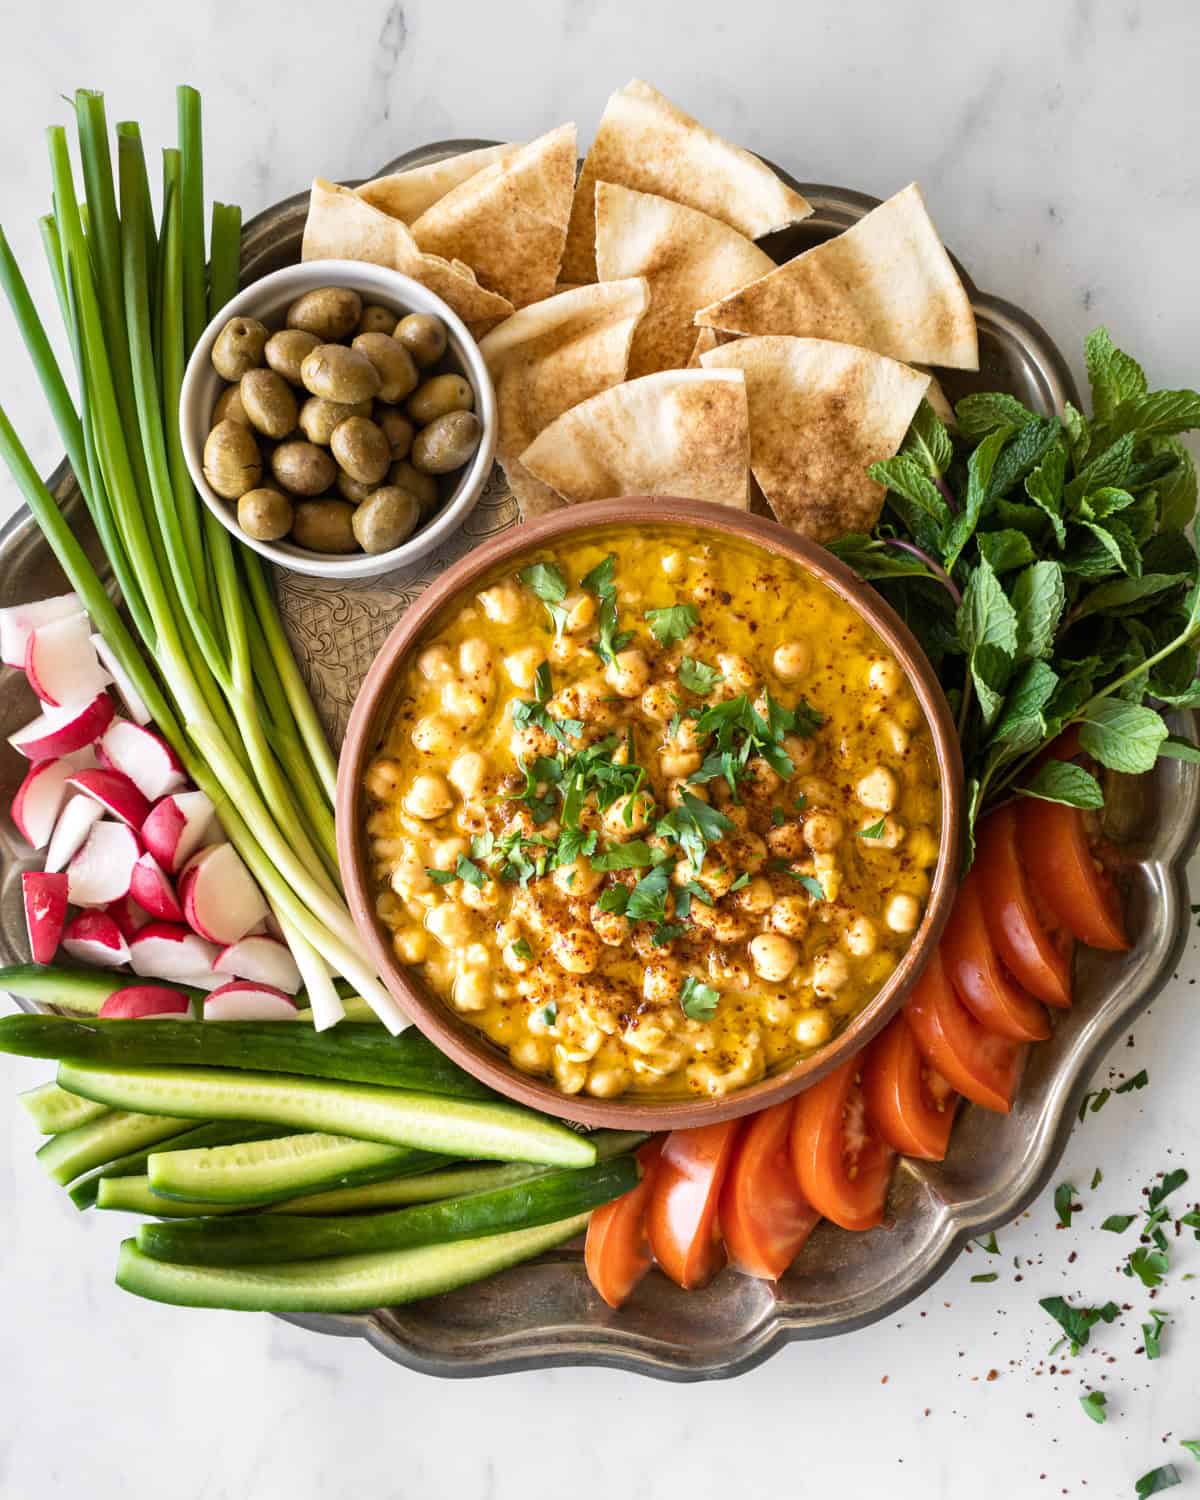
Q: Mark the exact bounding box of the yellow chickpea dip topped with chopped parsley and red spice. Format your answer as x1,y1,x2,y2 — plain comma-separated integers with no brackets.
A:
366,525,941,1100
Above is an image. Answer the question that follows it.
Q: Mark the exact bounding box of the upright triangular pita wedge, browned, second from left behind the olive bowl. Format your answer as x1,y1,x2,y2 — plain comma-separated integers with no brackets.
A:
413,125,575,308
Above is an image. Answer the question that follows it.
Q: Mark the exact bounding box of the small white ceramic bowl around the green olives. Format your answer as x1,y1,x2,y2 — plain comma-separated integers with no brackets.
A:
179,261,497,578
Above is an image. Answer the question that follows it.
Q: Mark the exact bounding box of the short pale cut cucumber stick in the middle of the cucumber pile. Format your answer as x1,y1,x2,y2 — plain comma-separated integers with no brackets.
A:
147,1134,449,1205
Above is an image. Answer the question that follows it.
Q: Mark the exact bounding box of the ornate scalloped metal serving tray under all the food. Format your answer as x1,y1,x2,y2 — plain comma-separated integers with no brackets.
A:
0,141,1200,1380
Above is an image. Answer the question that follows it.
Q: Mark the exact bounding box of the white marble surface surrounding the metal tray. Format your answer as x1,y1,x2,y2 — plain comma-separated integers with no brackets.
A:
0,0,1200,1500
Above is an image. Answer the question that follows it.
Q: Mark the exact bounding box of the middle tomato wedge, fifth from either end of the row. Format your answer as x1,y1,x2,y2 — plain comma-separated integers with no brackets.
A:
863,1016,959,1161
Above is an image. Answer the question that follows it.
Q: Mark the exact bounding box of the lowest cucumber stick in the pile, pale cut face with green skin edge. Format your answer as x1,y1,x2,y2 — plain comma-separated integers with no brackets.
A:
117,1212,588,1313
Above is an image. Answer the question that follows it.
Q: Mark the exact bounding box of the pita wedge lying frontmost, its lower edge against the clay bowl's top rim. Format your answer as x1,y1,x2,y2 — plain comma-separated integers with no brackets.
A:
521,371,750,510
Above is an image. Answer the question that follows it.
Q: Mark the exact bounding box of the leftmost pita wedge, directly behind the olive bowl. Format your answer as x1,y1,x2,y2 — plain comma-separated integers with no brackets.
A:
300,177,513,323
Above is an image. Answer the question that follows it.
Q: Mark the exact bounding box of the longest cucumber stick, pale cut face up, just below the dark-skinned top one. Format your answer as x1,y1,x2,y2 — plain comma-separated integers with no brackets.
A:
59,1068,596,1167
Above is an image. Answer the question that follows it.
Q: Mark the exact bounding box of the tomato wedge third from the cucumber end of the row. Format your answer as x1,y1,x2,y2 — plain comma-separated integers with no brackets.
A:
720,1100,821,1281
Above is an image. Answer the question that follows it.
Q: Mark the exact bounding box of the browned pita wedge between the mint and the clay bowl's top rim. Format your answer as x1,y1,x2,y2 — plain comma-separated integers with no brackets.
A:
702,336,929,542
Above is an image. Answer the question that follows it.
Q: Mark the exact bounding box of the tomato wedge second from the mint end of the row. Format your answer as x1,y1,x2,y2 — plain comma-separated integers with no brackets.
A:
975,803,1071,1010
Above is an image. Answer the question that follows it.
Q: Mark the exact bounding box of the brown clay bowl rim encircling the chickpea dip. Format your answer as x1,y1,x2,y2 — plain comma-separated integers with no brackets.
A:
338,495,963,1131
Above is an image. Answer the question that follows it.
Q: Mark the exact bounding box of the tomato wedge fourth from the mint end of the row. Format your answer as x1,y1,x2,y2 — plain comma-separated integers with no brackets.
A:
902,950,1022,1115
